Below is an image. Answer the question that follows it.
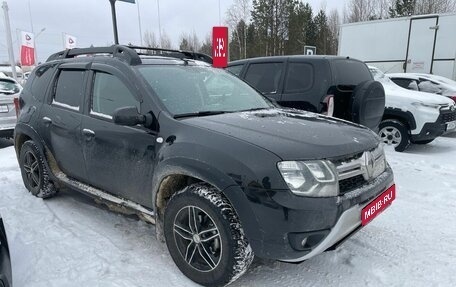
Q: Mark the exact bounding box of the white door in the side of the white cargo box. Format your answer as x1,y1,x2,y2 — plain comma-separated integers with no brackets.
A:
406,16,438,73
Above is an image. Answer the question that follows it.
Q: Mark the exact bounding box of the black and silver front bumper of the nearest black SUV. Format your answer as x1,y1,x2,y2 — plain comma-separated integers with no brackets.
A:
237,167,394,262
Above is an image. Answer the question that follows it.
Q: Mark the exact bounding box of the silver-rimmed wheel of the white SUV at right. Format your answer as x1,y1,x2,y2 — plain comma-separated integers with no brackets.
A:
378,120,410,152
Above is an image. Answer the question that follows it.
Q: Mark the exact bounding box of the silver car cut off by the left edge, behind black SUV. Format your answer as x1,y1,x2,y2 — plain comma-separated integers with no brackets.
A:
0,78,22,138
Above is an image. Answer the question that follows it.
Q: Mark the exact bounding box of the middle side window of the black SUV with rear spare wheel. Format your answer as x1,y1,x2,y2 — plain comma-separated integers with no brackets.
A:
245,63,283,94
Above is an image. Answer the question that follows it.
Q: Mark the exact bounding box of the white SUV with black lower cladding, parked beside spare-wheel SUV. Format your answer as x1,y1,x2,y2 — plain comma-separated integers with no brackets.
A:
369,66,456,151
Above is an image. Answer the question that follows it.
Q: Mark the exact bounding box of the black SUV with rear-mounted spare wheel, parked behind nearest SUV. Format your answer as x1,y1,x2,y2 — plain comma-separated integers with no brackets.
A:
226,55,385,131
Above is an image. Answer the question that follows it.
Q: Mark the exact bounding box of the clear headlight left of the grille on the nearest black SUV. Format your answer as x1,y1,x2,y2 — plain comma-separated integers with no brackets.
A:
277,160,339,197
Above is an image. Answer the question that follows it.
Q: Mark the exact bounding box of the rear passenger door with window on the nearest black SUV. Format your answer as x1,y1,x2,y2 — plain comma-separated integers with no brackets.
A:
40,64,87,181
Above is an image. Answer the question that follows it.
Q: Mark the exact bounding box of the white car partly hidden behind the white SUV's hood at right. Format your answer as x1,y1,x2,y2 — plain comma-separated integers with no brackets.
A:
386,73,456,102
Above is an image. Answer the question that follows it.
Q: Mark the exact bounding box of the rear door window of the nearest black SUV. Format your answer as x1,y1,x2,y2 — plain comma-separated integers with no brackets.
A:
53,70,85,110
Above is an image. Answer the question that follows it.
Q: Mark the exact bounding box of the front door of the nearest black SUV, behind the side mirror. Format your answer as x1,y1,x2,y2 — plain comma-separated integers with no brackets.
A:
81,65,156,207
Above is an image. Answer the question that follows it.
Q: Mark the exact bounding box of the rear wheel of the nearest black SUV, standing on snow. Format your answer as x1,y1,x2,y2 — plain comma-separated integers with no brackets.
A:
19,141,57,198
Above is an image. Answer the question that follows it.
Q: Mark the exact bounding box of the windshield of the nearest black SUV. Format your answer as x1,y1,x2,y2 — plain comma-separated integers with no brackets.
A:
138,65,272,116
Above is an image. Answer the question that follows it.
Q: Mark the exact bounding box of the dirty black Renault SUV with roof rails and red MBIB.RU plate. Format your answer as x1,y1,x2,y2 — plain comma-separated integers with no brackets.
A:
15,46,394,286
